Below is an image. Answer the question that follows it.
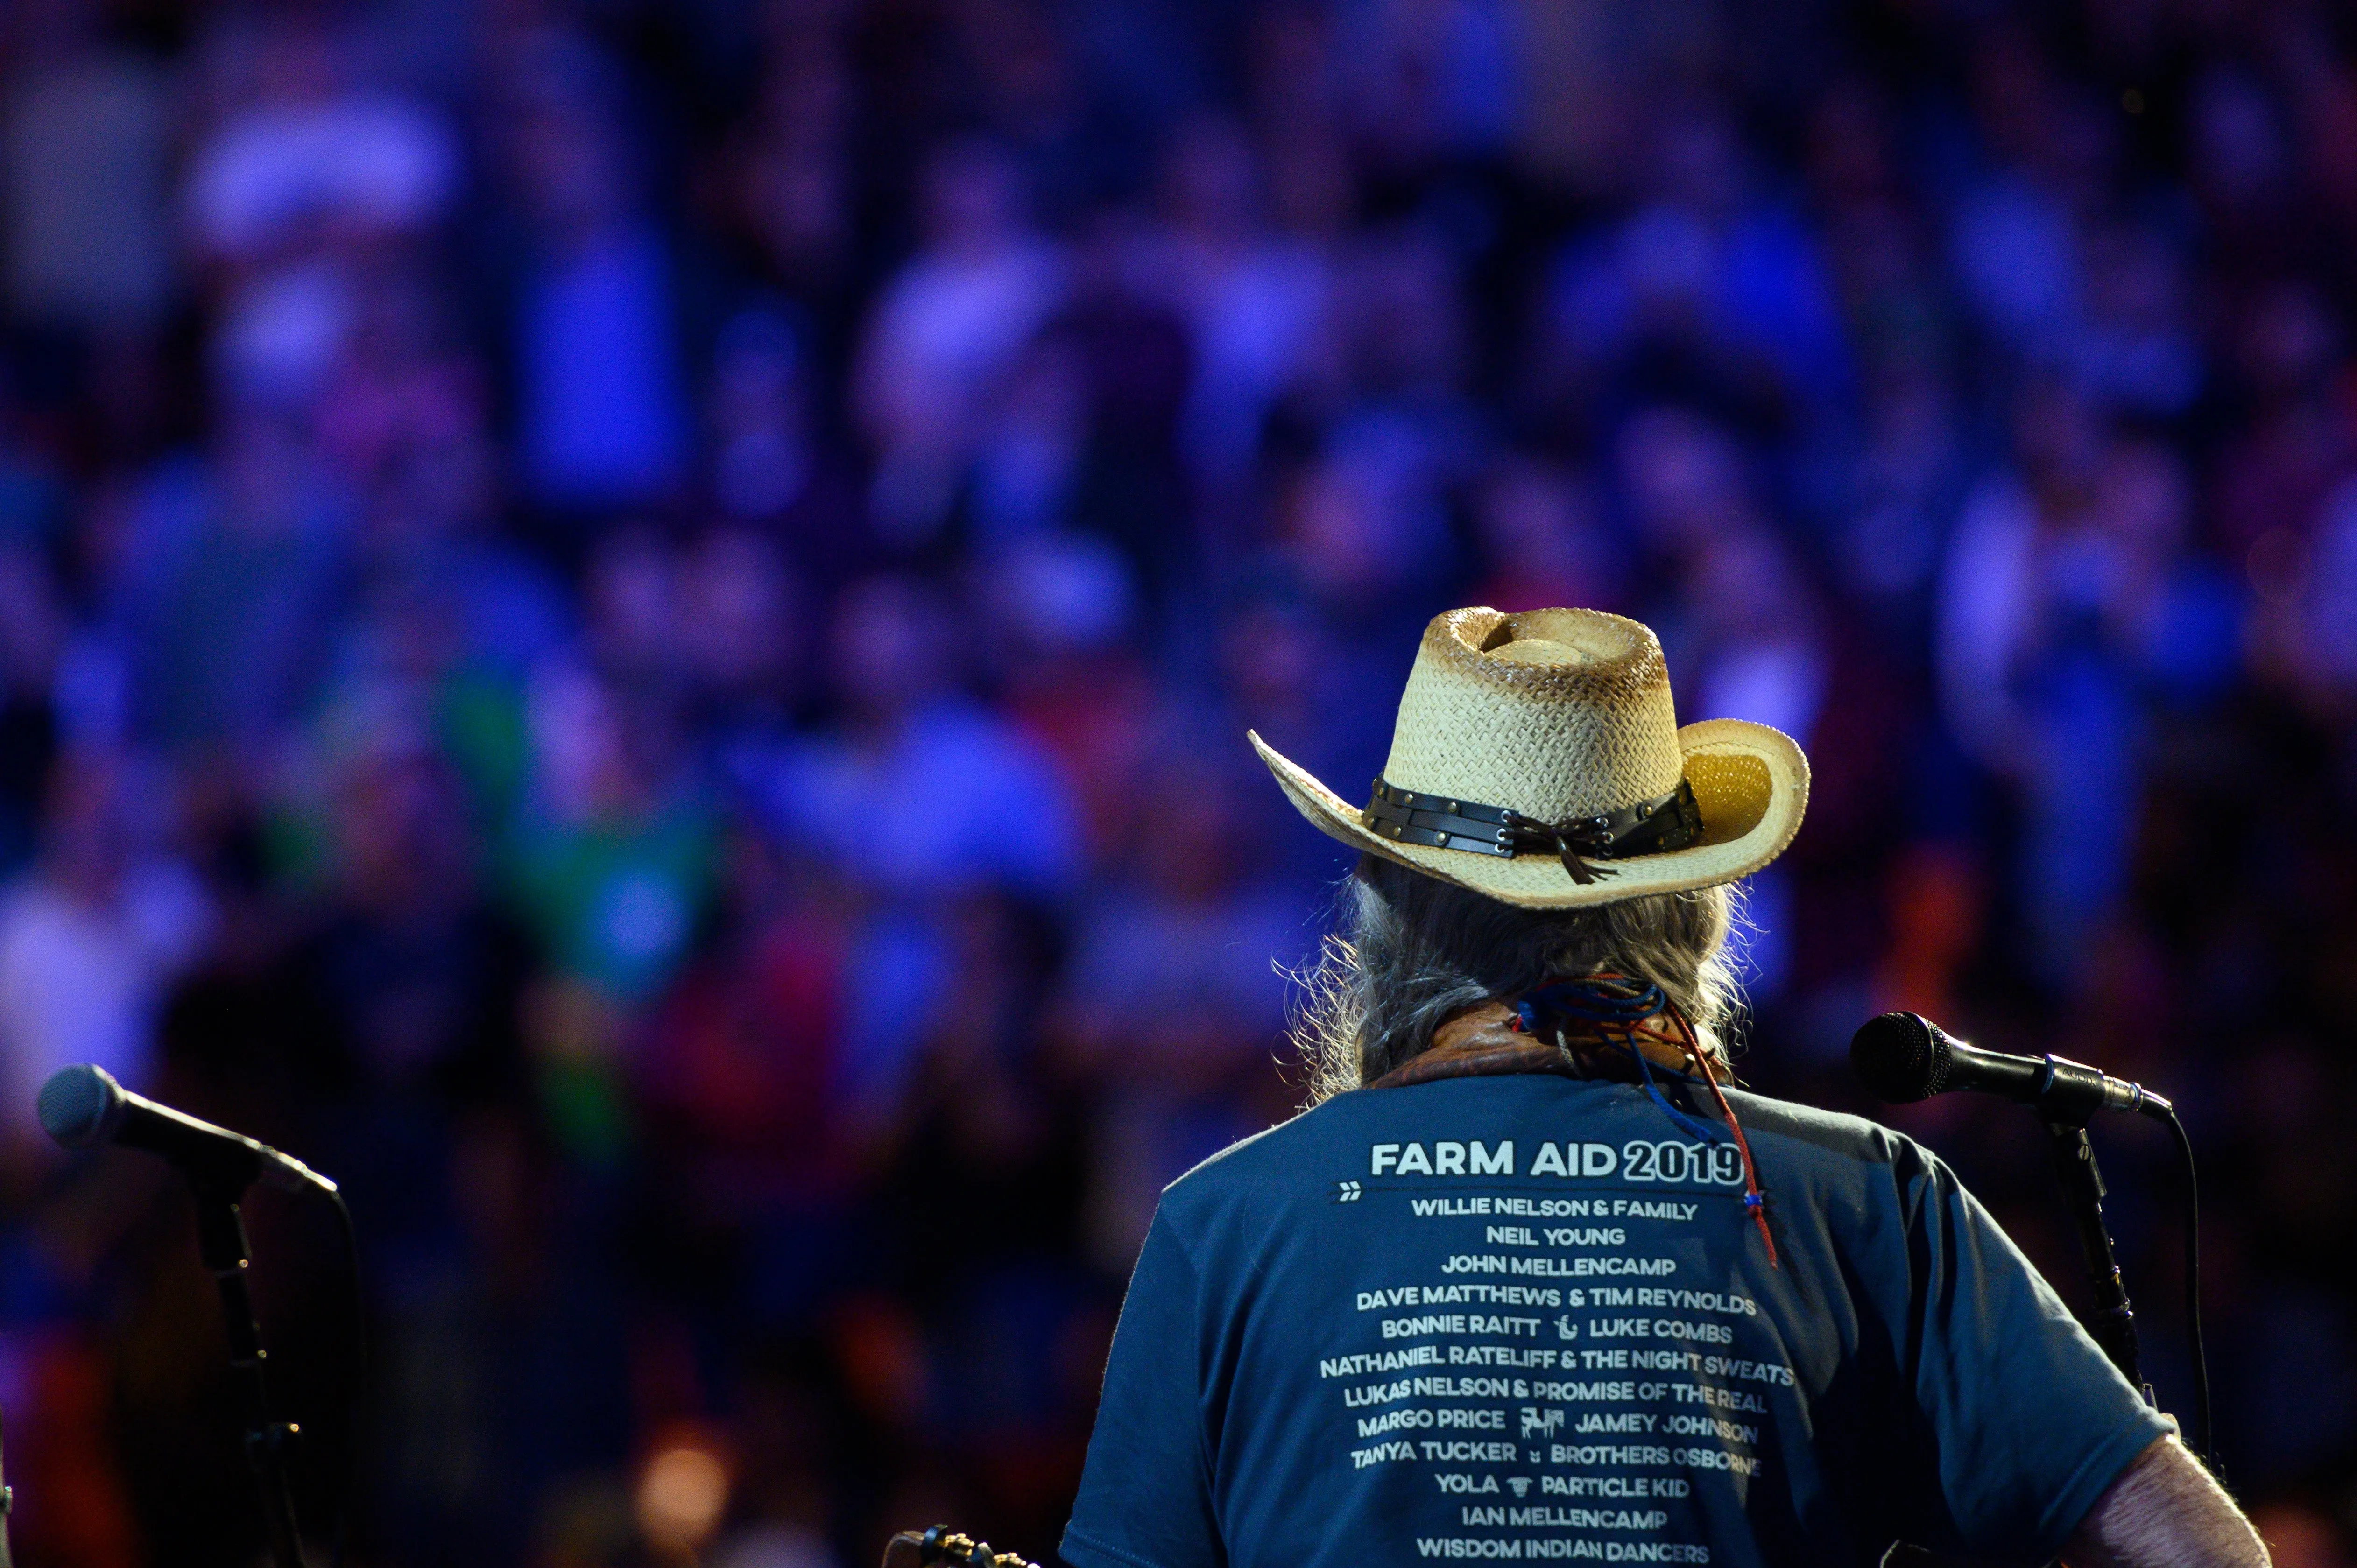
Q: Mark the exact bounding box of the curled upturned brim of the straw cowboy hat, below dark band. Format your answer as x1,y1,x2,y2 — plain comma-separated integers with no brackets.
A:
1247,719,1808,910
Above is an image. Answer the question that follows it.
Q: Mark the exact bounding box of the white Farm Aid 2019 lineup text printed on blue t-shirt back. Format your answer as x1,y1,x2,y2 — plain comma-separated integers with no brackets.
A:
1318,1141,1794,1563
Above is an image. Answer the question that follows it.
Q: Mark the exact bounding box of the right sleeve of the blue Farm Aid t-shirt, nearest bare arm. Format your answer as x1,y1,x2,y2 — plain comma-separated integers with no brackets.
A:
1900,1155,2175,1561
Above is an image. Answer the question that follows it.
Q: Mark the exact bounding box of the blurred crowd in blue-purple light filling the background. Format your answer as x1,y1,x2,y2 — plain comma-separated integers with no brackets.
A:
0,0,2357,1568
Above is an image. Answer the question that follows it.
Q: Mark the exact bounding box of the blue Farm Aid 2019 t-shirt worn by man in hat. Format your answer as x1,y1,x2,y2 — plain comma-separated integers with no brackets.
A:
1063,1075,2173,1568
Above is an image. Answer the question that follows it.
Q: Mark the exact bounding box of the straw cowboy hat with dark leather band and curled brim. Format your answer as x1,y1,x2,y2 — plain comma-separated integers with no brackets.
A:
1251,608,1808,910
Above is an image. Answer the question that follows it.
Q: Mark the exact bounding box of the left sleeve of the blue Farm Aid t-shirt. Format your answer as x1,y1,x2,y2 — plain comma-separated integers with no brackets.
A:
1061,1214,1228,1568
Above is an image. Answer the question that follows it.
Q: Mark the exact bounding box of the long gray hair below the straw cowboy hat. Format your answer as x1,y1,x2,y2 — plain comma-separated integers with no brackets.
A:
1291,856,1737,1106
